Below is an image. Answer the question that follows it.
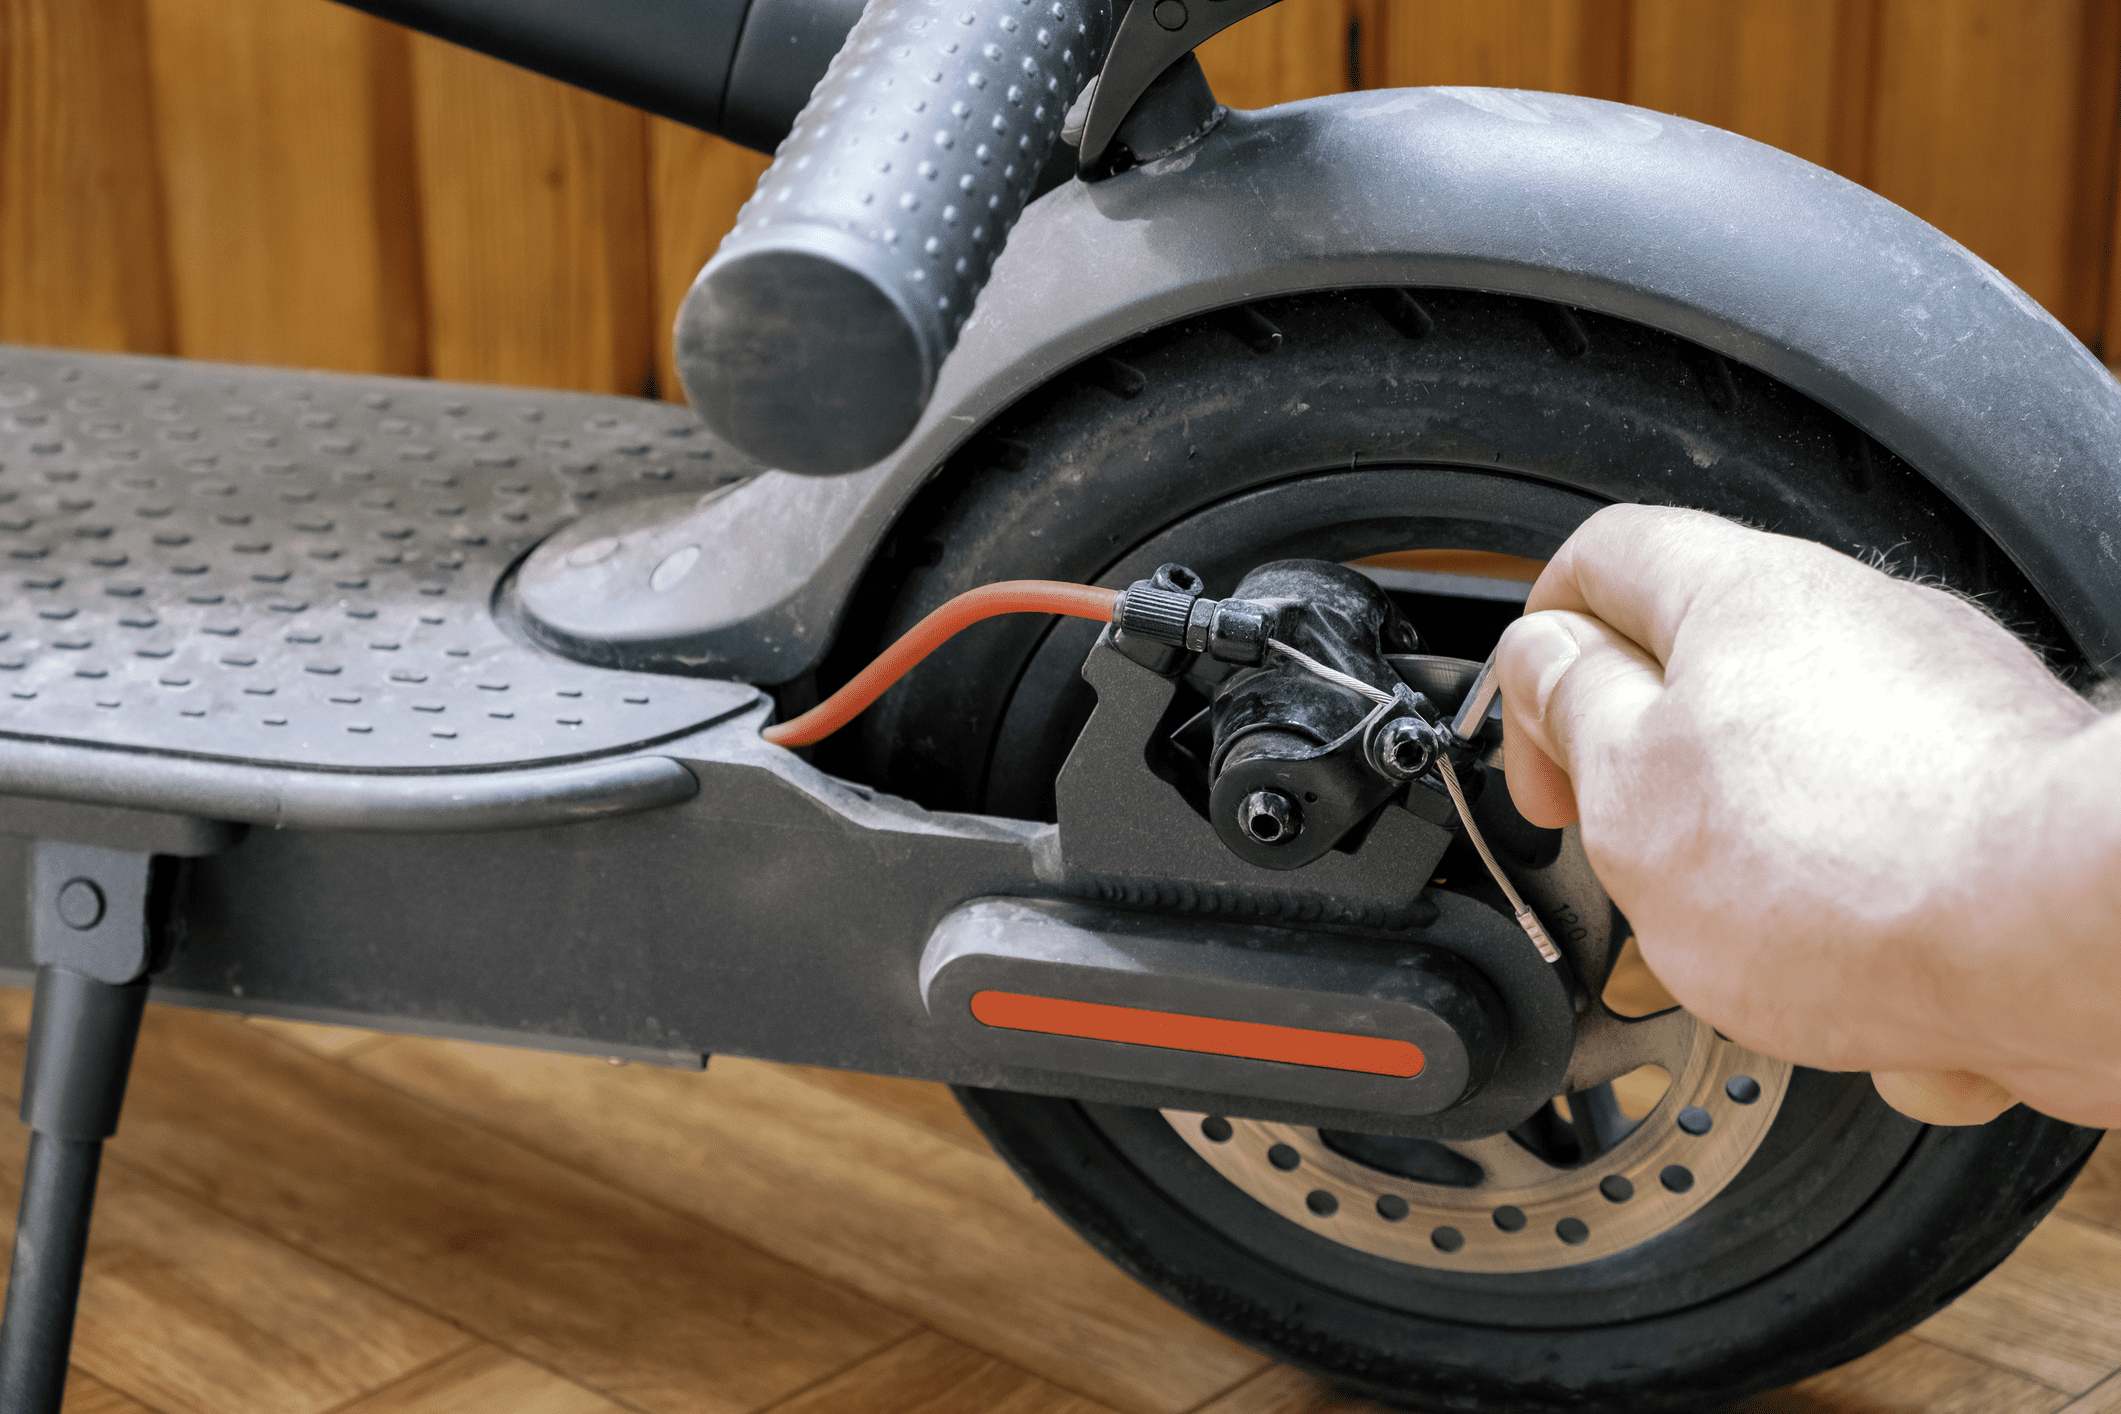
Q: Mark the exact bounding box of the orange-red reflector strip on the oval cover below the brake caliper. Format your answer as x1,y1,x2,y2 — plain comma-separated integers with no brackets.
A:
971,992,1425,1079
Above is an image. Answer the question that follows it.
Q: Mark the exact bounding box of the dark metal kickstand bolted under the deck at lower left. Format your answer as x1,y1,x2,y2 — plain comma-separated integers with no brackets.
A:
0,844,176,1414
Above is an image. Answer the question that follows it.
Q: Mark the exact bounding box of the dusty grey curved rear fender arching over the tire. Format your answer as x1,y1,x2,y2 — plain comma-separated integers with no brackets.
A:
518,89,2121,683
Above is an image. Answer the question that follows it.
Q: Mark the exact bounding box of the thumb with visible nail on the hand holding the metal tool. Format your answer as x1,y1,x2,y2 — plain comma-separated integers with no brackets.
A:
1495,608,1665,827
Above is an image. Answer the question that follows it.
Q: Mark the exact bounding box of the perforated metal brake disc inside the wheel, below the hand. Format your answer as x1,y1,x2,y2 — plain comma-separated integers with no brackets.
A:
1164,1022,1790,1272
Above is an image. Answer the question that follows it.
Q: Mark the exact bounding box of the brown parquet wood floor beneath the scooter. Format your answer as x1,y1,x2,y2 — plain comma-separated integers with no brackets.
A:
0,992,2121,1414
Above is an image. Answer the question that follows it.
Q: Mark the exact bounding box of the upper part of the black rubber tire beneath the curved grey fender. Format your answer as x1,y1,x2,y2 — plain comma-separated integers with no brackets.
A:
839,290,2066,818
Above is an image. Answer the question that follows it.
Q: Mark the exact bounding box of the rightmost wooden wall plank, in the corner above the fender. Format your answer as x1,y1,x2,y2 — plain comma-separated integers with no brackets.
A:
1871,0,2121,339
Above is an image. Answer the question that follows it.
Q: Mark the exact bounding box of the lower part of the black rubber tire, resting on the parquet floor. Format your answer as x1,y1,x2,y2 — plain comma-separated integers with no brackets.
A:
959,1090,2098,1414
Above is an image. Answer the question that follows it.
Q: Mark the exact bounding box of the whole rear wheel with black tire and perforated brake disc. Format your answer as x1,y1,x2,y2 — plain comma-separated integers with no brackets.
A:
842,290,2096,1412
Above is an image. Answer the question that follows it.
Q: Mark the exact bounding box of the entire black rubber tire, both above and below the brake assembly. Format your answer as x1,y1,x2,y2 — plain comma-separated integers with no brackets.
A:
831,290,2098,1414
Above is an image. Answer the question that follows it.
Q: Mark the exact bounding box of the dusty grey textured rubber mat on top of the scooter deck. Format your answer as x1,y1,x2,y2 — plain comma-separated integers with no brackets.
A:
0,350,755,770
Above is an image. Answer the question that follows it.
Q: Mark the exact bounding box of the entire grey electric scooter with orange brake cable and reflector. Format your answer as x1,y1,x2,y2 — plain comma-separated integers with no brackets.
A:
0,0,2121,1414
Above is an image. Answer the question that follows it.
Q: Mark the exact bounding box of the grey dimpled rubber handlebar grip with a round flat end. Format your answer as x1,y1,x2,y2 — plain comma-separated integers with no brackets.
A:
677,0,1114,475
